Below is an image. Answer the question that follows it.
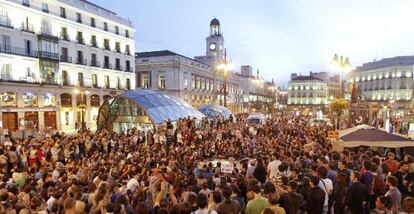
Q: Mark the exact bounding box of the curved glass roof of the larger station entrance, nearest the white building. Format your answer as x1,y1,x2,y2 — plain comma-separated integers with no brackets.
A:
101,90,204,127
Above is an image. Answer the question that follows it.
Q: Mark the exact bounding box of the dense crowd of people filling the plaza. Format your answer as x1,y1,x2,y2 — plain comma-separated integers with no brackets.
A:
0,115,414,214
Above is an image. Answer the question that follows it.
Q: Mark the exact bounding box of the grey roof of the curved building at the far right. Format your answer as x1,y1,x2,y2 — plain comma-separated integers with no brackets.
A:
354,56,414,72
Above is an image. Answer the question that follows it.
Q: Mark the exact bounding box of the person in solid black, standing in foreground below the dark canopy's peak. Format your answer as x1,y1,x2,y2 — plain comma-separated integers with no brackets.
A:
345,171,369,214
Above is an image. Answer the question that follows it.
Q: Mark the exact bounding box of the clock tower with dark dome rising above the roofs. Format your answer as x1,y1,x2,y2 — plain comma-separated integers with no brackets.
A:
206,18,224,61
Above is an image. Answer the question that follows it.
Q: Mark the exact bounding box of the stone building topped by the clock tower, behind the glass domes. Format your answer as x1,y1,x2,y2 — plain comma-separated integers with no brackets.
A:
135,19,241,113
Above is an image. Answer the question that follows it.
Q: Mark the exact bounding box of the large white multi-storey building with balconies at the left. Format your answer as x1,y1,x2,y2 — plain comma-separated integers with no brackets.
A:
0,0,135,135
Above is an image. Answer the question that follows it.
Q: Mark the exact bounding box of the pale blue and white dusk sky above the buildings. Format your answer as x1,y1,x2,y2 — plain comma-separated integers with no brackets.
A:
94,0,414,85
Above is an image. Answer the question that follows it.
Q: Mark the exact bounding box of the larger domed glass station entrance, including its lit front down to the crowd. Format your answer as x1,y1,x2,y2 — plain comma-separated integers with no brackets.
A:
98,90,204,130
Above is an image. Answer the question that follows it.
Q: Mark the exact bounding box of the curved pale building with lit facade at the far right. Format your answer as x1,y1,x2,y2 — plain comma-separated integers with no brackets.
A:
348,56,414,115
